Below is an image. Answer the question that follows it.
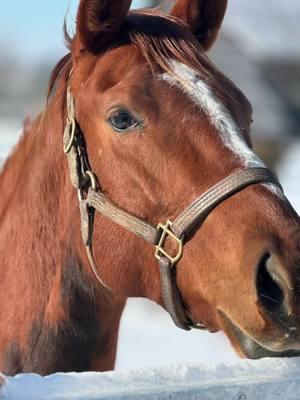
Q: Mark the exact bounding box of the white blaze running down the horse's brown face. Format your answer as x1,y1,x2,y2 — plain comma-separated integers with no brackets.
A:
159,60,282,194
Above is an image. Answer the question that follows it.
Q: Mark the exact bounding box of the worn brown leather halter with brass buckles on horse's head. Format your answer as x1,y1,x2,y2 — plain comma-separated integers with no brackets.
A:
64,87,282,330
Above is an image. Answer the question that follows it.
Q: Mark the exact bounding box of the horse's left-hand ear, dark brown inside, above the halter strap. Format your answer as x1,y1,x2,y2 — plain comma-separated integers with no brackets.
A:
75,0,131,52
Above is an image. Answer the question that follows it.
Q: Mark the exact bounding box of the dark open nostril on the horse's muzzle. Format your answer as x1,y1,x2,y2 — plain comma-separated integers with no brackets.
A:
256,253,284,313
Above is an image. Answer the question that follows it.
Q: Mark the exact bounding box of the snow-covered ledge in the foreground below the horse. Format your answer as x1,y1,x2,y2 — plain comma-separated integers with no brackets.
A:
0,358,300,400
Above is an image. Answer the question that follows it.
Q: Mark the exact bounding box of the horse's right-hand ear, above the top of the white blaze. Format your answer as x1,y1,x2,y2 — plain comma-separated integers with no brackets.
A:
171,0,227,51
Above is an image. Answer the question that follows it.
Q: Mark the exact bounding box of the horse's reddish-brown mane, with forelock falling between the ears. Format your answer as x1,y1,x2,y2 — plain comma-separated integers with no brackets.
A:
47,9,225,99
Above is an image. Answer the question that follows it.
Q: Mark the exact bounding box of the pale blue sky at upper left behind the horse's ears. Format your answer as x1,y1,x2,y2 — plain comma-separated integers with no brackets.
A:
0,0,149,62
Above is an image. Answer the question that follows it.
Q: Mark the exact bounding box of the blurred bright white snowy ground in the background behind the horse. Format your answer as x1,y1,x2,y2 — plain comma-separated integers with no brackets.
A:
0,121,300,372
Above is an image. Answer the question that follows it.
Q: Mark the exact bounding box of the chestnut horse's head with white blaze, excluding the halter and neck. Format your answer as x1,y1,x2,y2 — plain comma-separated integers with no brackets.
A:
56,0,300,358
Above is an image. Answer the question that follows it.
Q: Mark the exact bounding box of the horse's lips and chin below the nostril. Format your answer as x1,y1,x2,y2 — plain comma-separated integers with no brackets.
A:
221,313,300,360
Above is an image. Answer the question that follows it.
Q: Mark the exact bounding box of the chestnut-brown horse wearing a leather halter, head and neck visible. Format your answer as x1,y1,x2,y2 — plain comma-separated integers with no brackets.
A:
0,0,300,375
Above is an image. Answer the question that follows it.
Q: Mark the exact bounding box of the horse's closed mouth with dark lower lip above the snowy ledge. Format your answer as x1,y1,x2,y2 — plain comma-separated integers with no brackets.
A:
222,313,300,360
